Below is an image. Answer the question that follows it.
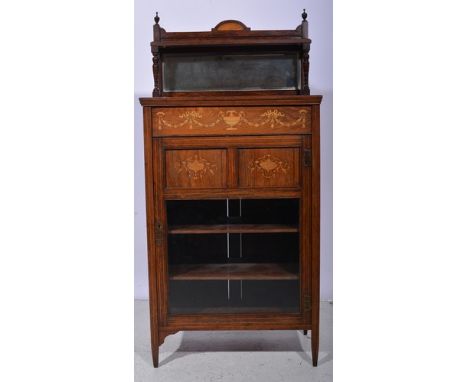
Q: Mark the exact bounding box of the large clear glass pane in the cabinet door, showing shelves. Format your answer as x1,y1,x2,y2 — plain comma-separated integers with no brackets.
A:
166,199,300,314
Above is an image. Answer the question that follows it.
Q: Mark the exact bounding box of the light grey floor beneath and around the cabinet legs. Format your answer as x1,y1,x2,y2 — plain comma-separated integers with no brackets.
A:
135,300,333,382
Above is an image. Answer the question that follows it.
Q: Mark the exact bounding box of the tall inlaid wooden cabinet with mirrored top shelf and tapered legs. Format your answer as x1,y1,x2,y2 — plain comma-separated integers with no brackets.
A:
140,11,322,367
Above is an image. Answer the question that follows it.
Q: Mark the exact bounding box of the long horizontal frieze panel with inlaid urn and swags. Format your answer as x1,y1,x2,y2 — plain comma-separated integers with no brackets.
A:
152,106,311,136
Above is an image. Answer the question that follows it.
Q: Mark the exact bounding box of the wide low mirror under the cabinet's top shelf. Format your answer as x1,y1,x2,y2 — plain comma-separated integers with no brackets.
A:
163,53,300,92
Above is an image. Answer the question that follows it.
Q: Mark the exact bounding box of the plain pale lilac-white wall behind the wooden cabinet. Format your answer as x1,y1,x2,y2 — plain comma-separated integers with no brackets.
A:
134,0,333,300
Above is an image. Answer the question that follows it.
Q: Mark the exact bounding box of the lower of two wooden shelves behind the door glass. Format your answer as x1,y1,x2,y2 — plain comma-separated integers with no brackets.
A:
169,263,299,280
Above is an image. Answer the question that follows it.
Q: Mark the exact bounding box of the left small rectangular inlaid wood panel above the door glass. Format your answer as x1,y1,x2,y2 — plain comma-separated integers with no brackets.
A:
165,149,226,188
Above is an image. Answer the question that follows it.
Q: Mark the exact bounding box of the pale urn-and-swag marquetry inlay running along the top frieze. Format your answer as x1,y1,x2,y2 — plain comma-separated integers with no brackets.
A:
155,107,309,131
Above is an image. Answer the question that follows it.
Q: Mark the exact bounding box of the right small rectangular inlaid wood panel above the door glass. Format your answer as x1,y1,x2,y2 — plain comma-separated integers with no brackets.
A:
239,148,300,188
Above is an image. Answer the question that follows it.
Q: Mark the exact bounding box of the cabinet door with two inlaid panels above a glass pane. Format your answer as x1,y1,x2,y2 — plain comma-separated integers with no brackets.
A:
156,137,310,316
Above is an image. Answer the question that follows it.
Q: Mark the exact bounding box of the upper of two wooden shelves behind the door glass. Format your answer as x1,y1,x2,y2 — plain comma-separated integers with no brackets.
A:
168,224,299,234
